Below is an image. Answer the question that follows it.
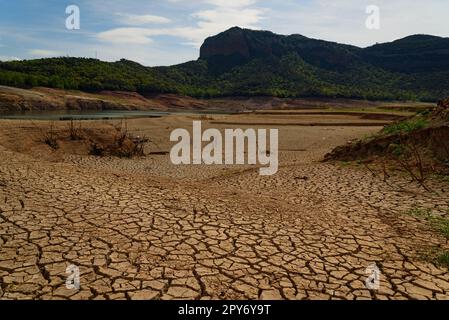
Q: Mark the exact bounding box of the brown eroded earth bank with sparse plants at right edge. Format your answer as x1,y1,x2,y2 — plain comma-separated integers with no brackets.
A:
326,100,449,192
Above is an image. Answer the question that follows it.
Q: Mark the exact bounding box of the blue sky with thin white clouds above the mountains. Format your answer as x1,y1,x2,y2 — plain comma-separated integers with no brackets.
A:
0,0,449,66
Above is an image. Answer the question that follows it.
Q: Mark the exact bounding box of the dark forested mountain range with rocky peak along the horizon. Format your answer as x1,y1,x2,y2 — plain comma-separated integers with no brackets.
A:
0,27,449,101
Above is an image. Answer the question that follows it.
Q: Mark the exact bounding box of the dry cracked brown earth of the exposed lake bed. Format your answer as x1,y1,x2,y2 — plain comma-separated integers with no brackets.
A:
0,120,449,299
